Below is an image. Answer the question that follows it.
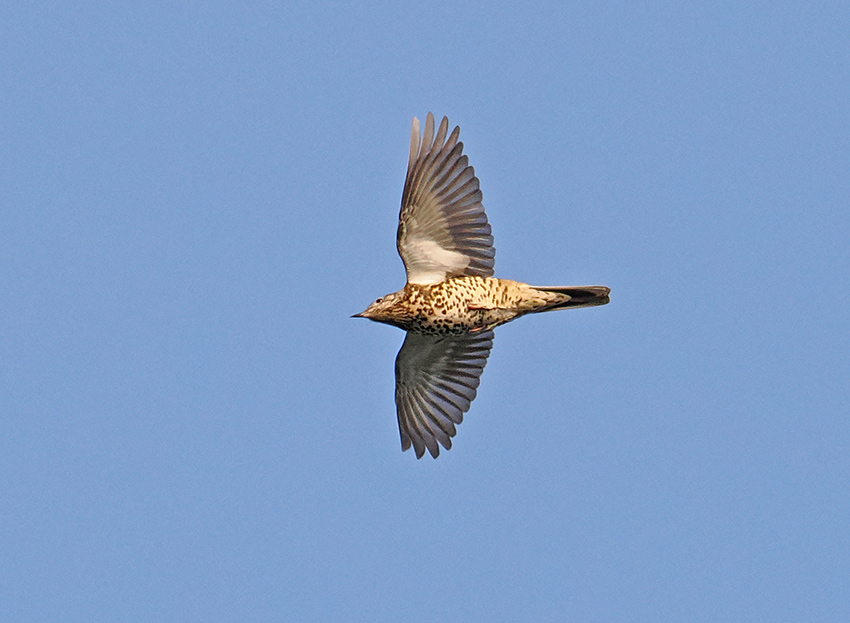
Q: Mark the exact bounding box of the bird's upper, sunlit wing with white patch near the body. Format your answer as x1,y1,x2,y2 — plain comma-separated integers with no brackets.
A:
396,113,496,284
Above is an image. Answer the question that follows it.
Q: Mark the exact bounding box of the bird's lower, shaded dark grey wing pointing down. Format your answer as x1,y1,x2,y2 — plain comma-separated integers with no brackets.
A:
395,331,493,458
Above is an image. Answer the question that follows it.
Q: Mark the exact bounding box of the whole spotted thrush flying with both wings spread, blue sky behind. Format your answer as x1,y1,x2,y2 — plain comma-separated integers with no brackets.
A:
352,112,611,459
